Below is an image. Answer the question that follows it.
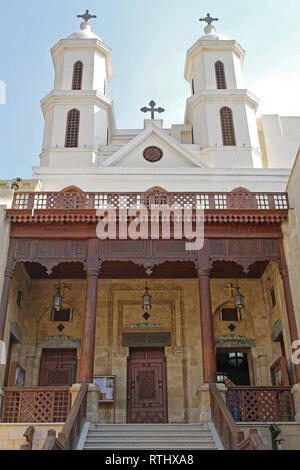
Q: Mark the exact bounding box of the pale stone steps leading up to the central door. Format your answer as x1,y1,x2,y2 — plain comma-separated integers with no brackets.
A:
81,423,221,450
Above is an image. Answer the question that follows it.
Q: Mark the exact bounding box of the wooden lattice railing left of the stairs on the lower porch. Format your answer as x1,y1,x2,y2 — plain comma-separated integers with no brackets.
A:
1,387,71,423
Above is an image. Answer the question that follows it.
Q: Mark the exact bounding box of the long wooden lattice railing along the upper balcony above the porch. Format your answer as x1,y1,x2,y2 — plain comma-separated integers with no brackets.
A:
12,191,289,211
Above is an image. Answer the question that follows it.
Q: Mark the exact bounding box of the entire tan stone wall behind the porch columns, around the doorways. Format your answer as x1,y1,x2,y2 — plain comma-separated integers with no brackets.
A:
0,265,289,423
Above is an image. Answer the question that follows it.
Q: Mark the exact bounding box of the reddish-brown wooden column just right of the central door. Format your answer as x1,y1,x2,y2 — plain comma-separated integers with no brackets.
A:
197,240,217,383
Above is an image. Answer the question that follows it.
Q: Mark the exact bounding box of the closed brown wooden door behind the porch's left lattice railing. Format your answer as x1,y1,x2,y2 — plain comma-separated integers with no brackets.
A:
39,349,77,387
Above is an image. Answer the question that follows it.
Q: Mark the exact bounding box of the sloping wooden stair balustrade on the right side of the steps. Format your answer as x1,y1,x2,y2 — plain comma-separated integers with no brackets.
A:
209,384,266,450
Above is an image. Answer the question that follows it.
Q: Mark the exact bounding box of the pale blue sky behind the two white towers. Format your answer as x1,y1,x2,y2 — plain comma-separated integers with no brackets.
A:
0,0,300,180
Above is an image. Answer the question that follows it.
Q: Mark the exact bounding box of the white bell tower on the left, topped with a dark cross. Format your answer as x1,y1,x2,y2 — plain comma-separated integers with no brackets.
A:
40,10,114,167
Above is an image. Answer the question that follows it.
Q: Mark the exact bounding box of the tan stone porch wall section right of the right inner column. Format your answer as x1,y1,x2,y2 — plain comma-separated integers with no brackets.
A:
211,270,290,386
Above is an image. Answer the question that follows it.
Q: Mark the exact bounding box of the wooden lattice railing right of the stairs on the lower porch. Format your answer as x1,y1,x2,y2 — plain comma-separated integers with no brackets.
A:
227,387,295,422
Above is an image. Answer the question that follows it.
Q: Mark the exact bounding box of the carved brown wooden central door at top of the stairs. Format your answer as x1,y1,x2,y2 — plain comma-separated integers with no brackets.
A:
127,349,168,424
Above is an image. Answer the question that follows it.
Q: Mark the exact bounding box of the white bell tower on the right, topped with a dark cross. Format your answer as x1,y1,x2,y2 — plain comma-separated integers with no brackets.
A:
185,13,262,168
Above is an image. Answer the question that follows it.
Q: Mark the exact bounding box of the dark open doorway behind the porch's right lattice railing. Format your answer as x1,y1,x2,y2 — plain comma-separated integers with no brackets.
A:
217,348,250,385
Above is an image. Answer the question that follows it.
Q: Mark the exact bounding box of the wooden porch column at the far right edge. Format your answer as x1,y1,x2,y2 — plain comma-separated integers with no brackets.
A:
280,240,300,383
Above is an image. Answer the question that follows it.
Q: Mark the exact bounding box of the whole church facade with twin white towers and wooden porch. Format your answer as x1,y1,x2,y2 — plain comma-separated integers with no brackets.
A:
0,15,300,448
